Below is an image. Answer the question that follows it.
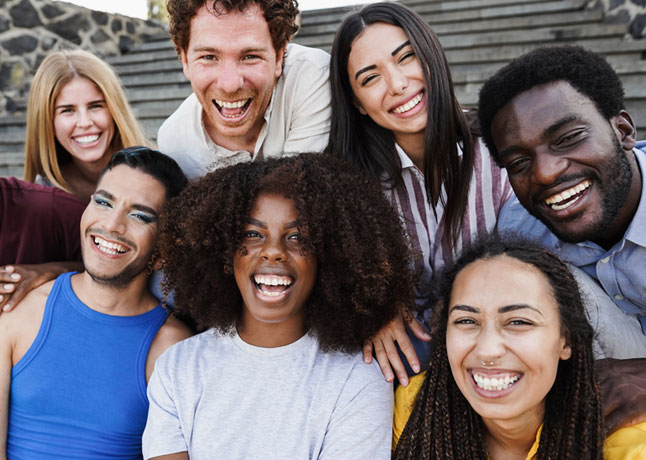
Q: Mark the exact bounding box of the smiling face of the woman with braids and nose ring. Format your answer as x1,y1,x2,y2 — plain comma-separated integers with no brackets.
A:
446,255,571,423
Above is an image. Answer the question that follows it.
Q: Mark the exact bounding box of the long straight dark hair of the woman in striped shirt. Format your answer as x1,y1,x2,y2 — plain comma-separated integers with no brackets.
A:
326,2,475,252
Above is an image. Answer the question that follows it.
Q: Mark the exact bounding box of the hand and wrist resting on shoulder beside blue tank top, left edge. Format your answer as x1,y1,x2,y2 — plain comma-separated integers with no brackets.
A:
0,262,83,313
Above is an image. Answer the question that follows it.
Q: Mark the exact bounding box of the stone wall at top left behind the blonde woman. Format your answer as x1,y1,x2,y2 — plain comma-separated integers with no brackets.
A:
0,0,166,116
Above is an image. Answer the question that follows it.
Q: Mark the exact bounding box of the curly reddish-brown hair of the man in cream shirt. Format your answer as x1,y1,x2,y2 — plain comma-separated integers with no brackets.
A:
166,0,298,54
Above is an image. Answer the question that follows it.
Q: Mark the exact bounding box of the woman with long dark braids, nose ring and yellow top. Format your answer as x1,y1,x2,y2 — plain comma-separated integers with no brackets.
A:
394,237,646,460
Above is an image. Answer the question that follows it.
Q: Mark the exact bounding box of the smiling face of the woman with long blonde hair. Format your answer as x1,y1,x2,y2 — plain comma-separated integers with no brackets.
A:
54,77,115,170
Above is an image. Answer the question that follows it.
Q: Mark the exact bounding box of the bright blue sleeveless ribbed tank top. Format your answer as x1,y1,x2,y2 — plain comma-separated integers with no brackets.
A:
7,273,168,460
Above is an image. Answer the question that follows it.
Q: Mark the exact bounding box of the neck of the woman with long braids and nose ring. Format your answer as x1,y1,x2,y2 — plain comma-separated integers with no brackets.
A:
483,411,543,460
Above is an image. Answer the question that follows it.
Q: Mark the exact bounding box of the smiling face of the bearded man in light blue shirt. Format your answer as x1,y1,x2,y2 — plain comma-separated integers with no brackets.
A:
491,81,641,250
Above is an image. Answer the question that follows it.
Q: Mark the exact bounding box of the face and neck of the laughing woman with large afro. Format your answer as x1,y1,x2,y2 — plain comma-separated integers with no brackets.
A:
233,193,317,346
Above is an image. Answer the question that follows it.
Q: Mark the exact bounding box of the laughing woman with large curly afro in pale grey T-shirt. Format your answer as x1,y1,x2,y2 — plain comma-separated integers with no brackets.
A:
143,154,414,460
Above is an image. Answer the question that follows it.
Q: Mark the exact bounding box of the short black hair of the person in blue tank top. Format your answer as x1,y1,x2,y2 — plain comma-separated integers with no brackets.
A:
97,146,188,199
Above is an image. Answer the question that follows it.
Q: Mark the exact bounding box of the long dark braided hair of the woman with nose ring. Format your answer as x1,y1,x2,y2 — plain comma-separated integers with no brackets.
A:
394,235,604,460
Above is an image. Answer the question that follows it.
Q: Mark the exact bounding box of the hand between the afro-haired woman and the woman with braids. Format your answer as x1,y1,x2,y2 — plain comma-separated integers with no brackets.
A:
363,308,431,386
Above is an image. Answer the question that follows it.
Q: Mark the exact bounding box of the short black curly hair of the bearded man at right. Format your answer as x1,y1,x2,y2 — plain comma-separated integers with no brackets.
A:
478,45,625,166
